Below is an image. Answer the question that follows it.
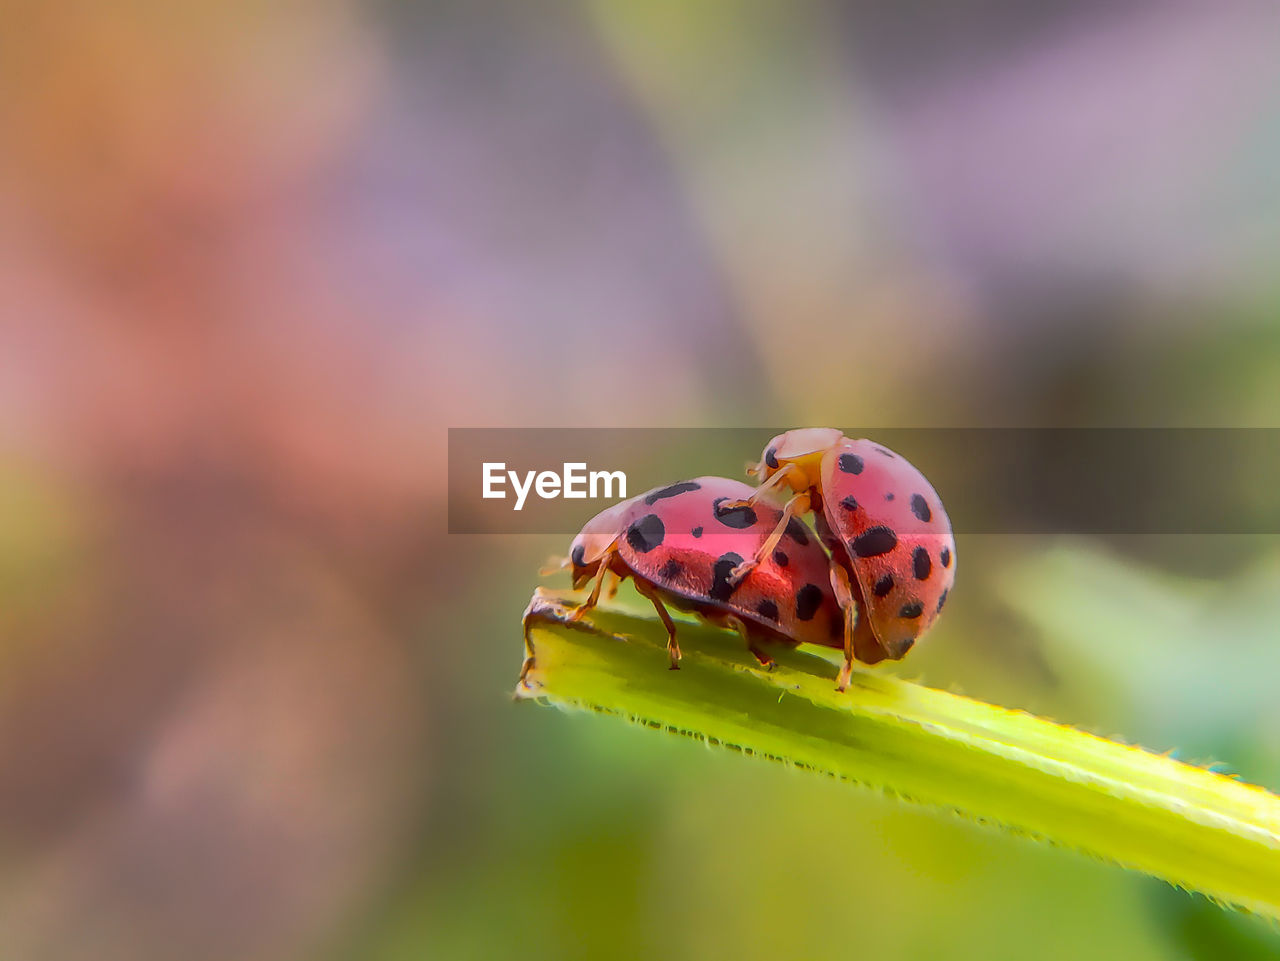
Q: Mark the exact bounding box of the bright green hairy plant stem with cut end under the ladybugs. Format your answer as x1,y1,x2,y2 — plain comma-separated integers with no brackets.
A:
516,591,1280,917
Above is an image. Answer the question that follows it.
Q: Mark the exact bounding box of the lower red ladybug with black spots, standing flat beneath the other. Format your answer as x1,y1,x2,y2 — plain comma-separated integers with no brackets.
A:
525,477,844,672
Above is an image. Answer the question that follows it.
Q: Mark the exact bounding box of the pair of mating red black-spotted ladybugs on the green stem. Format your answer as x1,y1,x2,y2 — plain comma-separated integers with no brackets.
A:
529,427,956,691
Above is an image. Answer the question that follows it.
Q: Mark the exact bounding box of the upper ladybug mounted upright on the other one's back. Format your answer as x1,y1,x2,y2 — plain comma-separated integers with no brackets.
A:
731,427,956,687
